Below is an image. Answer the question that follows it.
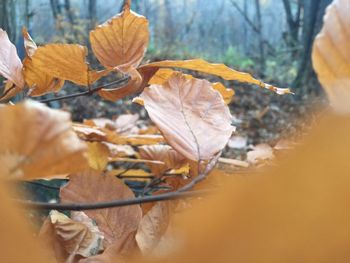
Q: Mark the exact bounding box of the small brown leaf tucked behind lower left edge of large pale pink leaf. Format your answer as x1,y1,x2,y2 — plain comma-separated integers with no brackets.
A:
139,145,187,176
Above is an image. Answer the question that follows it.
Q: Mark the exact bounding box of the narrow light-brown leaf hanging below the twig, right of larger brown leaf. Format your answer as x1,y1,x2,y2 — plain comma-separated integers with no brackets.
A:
136,202,172,254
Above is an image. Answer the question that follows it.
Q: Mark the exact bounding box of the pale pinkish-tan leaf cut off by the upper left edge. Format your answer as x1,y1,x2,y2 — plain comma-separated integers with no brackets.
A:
0,28,24,89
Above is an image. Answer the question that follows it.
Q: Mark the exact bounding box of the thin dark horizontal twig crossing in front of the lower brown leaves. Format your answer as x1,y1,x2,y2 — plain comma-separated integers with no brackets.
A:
16,190,213,211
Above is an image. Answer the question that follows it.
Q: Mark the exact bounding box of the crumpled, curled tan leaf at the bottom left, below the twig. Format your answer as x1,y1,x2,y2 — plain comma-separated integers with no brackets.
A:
39,210,104,262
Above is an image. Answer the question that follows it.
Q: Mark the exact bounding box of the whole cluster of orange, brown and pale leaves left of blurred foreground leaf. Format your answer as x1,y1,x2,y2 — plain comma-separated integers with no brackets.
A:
0,0,296,262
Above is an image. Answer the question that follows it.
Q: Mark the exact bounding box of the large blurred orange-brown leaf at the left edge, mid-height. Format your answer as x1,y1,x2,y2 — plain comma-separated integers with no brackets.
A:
0,101,87,179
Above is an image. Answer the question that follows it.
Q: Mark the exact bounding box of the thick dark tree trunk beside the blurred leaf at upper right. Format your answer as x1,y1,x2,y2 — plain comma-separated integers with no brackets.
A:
293,0,332,94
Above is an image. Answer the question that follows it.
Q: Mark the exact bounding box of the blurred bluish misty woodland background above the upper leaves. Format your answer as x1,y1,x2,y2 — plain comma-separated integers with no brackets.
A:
0,0,331,97
